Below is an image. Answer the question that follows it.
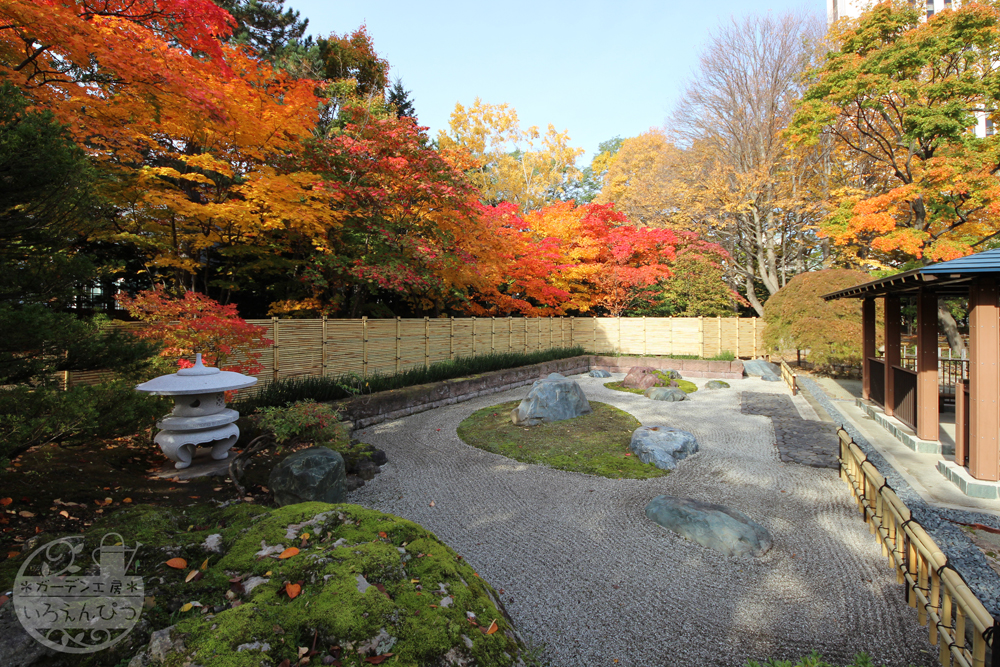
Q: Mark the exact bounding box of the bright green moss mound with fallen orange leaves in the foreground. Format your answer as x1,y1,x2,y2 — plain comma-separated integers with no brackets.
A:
0,503,523,667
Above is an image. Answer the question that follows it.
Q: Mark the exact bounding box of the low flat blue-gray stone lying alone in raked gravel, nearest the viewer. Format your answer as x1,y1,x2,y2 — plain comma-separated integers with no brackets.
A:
646,496,772,556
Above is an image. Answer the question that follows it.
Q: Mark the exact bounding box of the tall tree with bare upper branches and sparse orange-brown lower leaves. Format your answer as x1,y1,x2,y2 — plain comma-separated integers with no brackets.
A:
663,14,824,313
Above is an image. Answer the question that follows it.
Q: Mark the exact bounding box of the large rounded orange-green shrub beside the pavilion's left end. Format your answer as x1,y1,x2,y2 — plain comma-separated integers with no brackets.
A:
764,269,881,368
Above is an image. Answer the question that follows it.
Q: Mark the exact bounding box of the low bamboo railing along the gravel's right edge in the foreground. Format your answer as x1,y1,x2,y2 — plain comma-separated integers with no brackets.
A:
838,429,1000,667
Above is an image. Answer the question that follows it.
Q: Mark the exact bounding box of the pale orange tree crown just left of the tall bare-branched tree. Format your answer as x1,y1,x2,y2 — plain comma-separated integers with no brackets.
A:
594,128,676,227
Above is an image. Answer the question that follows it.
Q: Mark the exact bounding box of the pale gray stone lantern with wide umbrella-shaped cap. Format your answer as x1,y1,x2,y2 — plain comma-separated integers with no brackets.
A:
136,353,257,469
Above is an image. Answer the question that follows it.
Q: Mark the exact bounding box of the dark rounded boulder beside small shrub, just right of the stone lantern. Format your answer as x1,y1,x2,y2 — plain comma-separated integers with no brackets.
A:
268,447,347,507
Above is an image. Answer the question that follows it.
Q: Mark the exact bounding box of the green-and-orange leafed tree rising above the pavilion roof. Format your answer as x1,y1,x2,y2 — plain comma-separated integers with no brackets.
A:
791,3,1000,350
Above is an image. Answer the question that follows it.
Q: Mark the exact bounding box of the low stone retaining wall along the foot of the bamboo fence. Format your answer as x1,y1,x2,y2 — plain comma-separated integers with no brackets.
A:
333,355,743,429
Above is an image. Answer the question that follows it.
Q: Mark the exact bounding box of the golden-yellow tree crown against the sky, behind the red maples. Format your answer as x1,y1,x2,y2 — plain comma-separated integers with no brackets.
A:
438,98,583,212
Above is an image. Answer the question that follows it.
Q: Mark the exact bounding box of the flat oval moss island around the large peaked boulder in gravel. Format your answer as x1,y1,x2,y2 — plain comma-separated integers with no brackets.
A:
458,401,668,479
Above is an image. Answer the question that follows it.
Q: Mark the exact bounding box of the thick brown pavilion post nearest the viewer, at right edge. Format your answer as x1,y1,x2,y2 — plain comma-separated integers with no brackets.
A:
968,278,1000,481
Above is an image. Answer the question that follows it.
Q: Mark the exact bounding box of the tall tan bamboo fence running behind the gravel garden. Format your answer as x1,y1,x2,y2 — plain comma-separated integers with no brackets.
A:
65,317,764,386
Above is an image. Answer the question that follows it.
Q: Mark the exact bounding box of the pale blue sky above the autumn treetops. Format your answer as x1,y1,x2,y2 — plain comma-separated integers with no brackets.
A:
285,0,826,166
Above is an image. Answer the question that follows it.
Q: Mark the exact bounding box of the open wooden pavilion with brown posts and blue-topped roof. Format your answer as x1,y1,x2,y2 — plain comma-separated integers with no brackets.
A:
823,250,1000,481
